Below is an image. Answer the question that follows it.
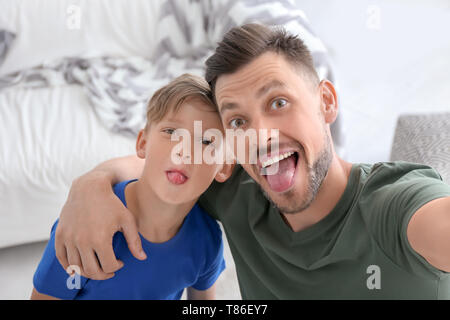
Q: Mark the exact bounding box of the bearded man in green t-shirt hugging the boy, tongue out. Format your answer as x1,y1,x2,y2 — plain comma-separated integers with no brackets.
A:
56,24,450,299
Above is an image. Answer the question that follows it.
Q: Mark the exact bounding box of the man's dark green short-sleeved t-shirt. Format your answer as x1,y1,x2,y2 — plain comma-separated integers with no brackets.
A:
200,162,450,299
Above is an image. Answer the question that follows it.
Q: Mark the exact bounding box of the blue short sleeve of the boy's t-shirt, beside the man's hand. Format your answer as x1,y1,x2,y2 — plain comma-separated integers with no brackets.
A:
33,221,88,300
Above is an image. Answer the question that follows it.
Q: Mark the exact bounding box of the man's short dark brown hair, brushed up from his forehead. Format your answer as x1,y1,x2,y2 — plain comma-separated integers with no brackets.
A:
205,23,319,99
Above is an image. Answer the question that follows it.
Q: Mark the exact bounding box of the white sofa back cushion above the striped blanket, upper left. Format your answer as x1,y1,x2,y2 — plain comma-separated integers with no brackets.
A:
0,0,164,75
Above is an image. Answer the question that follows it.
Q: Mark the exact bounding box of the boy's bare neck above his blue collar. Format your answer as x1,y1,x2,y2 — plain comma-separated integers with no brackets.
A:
125,178,195,243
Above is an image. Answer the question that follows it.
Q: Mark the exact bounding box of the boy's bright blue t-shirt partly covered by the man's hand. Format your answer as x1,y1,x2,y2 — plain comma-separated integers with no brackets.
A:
33,180,225,300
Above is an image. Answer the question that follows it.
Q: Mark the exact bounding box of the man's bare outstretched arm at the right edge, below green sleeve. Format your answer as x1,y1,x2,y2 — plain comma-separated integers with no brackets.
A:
407,197,450,272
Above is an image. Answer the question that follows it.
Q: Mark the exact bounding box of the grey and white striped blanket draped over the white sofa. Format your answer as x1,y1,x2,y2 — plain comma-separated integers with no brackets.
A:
0,0,341,147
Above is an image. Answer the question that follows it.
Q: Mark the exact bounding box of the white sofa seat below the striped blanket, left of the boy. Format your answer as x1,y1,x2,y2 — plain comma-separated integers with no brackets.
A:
0,86,135,247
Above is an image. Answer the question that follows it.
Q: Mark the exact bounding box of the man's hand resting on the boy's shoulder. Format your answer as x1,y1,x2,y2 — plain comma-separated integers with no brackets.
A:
55,171,146,280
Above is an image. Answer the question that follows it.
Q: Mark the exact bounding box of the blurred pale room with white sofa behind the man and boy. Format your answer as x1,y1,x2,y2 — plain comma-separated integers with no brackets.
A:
0,0,450,299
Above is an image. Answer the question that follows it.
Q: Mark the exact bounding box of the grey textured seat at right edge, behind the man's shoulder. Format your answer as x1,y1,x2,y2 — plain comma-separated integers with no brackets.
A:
391,113,450,184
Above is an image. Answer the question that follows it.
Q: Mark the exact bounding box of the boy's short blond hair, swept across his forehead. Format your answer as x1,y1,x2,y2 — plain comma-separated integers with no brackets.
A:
145,73,216,129
